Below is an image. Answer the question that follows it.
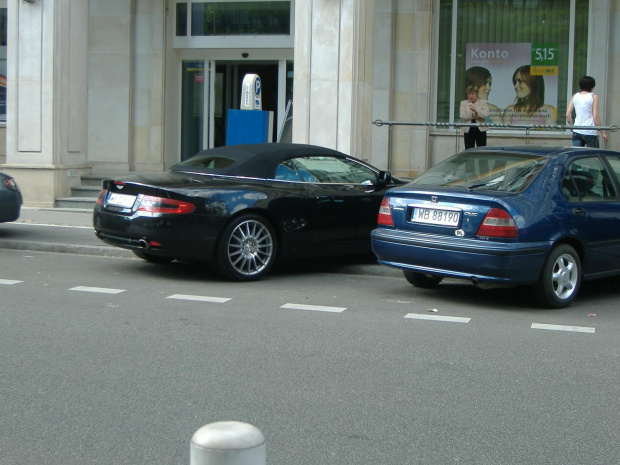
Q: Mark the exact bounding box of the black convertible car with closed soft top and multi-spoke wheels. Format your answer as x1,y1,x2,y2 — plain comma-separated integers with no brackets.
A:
93,143,405,281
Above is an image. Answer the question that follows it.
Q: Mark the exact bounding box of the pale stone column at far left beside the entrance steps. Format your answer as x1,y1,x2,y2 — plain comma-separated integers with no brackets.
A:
3,0,89,207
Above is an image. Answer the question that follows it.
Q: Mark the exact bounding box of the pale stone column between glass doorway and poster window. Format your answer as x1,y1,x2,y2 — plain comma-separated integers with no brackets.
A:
293,0,374,159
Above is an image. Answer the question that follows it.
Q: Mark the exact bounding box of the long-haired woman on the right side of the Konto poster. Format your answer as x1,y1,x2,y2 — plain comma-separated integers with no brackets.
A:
503,65,557,125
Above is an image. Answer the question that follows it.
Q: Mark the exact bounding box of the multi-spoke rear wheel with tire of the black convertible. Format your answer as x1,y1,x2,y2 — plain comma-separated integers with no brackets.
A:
215,214,276,281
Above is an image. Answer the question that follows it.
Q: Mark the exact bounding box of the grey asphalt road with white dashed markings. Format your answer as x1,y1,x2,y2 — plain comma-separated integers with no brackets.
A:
0,223,620,465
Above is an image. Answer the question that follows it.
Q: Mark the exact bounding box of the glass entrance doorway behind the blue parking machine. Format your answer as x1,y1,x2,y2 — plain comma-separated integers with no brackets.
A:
181,60,284,160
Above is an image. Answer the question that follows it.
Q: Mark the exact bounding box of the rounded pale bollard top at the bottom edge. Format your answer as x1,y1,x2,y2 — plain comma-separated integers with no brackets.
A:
189,421,266,465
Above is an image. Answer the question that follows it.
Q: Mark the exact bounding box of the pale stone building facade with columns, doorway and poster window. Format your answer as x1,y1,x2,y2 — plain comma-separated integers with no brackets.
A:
0,0,620,207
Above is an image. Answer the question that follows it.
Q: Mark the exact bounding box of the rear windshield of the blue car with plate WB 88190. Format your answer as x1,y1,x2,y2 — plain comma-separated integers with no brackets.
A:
411,151,548,192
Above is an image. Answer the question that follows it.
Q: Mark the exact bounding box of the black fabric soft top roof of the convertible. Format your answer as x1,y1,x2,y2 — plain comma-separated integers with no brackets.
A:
170,143,346,178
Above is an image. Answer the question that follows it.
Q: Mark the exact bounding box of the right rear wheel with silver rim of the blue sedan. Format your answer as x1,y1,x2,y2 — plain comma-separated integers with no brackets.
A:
534,244,581,308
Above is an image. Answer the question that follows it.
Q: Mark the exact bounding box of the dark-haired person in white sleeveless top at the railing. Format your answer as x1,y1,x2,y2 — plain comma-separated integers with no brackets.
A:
566,76,607,148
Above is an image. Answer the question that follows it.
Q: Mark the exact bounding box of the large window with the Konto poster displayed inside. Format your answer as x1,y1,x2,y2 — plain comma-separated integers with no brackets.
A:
437,0,589,125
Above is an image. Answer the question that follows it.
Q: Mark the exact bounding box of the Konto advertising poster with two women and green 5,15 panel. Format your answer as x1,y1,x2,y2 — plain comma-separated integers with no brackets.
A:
459,43,558,125
